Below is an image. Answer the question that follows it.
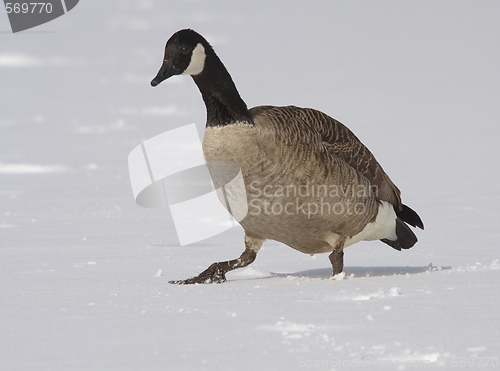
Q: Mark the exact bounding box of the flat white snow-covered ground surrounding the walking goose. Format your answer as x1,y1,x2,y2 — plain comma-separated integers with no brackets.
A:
0,0,500,371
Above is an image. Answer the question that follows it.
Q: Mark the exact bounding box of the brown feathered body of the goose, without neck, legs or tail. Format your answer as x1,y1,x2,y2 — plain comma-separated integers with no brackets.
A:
203,106,400,254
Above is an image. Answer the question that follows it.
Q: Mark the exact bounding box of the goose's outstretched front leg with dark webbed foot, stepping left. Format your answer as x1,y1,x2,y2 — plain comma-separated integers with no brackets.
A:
169,235,264,285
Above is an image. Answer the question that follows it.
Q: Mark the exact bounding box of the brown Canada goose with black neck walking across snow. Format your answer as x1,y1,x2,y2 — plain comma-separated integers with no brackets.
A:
151,29,424,284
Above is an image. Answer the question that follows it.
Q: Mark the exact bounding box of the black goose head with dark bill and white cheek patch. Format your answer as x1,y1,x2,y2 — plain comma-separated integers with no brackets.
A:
151,29,211,86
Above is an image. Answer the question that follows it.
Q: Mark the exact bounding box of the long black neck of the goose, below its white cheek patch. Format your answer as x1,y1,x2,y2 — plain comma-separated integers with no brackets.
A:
192,49,253,127
